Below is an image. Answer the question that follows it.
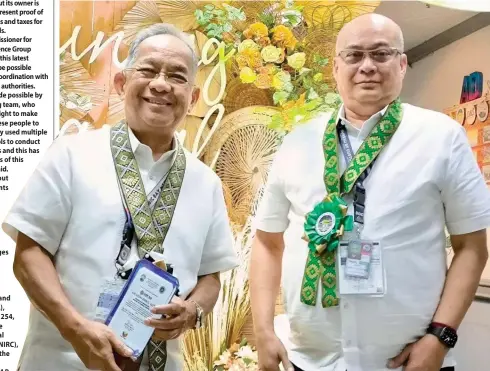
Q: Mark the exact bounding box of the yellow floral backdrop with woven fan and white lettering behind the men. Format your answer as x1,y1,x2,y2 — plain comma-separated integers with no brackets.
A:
59,0,379,371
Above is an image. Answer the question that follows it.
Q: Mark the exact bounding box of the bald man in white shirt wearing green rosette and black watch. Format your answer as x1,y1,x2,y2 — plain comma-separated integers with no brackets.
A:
250,14,490,371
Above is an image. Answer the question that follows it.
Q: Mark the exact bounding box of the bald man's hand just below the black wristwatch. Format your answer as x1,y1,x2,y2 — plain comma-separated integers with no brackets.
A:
388,335,448,371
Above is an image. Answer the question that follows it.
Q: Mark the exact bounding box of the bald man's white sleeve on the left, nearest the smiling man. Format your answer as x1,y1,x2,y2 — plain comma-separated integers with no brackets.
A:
254,137,291,233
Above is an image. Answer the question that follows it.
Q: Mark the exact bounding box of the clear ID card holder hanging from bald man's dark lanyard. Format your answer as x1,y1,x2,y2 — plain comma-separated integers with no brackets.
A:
337,239,386,296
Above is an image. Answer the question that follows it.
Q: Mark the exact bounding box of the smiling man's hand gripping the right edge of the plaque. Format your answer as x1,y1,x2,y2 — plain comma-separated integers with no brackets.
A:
145,296,197,341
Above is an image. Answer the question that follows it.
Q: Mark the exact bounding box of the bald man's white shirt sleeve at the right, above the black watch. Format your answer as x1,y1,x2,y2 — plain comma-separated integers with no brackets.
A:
442,125,490,235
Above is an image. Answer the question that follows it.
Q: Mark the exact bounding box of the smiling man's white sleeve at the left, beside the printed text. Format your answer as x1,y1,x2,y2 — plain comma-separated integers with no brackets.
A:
2,137,71,255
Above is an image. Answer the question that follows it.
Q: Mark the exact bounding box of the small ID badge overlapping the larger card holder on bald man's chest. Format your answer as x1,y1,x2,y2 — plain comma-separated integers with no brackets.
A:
345,240,373,279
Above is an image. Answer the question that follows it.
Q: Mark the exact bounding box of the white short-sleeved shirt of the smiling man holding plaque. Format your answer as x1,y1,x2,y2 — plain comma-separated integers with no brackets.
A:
3,127,237,371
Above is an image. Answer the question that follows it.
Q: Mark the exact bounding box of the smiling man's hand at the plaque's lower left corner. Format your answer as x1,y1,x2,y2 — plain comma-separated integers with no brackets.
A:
66,320,132,371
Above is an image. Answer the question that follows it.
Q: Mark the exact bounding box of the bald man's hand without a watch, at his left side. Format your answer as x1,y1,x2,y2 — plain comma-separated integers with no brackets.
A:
257,333,294,371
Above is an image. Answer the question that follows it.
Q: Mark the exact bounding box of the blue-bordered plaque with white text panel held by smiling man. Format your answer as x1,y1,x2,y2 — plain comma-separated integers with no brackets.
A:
106,259,179,358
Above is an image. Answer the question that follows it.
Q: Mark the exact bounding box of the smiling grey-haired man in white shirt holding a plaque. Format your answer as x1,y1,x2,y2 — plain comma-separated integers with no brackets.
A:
3,24,237,371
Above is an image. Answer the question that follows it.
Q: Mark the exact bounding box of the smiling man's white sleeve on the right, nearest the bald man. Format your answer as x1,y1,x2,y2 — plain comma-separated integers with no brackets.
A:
198,178,238,276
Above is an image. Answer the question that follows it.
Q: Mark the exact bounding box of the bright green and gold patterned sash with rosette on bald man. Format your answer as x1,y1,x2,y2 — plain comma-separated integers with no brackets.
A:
301,99,403,308
